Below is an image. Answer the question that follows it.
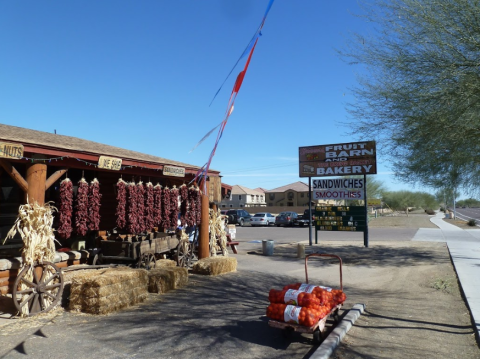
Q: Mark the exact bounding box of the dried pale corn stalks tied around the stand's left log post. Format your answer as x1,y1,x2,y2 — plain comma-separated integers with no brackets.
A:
5,202,57,316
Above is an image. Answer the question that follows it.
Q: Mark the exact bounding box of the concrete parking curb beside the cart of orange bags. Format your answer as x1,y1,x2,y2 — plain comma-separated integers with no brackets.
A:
310,303,365,359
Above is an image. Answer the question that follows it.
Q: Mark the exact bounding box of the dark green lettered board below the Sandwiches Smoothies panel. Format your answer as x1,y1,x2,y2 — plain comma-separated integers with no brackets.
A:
315,206,367,232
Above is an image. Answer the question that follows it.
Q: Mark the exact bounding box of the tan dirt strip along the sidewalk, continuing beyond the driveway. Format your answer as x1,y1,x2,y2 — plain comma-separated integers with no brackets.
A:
328,215,480,359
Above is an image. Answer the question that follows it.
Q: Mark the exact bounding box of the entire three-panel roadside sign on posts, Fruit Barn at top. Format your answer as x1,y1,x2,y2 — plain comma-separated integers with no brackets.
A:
298,141,377,247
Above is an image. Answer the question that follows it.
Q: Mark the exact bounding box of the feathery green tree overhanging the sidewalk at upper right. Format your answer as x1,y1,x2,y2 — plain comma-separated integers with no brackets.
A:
340,0,480,197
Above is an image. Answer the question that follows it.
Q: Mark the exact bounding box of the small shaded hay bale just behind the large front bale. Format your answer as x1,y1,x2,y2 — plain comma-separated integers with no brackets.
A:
148,267,188,294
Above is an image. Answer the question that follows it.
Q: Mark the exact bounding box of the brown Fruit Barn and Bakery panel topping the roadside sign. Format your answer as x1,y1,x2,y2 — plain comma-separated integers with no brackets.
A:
298,141,377,177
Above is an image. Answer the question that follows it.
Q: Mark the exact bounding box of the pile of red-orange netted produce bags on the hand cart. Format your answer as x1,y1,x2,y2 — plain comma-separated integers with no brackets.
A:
267,283,347,327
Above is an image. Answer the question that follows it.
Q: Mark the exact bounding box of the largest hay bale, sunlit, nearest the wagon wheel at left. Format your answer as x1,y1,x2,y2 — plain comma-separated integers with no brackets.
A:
69,267,148,314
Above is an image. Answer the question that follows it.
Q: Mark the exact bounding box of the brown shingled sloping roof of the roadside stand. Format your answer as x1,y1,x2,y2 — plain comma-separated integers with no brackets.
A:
0,124,218,172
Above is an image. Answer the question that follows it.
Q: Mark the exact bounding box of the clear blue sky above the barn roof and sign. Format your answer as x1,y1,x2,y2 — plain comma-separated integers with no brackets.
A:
0,0,423,194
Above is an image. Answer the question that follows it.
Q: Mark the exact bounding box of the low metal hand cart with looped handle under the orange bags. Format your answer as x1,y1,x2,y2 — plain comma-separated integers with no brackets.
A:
268,253,343,344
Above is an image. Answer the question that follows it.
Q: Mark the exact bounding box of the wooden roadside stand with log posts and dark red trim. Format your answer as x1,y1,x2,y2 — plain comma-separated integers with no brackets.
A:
0,124,222,306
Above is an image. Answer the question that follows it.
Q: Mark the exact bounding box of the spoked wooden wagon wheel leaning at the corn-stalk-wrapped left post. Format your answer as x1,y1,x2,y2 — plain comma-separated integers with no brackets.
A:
12,262,64,316
